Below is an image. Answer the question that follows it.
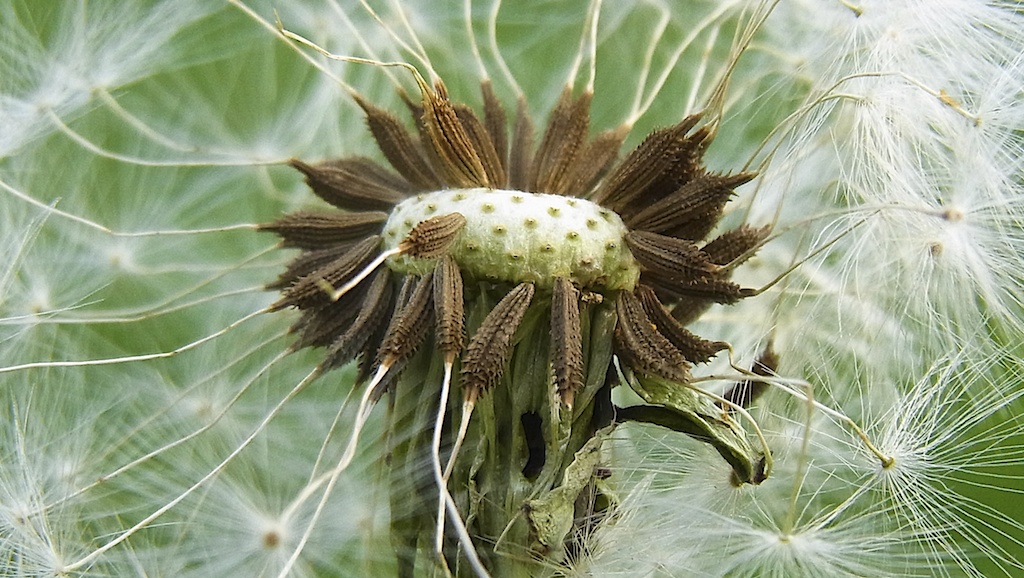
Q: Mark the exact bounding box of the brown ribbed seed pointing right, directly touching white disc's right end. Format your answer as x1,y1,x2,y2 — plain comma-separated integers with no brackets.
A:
626,231,718,282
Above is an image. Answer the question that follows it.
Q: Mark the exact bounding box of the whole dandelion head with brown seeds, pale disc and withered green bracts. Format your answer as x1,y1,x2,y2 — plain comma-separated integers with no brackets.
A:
263,77,767,572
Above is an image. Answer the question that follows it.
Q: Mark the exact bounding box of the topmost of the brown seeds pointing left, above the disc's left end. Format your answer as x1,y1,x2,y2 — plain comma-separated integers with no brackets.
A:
289,157,411,211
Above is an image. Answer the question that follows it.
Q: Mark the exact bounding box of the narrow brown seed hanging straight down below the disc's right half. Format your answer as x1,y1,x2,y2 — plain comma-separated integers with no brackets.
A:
551,277,583,407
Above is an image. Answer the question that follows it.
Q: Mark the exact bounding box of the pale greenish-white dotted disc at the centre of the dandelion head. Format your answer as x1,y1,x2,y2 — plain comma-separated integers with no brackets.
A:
384,189,640,290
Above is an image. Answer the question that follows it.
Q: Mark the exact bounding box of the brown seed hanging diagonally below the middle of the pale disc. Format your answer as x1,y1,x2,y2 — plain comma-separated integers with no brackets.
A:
462,283,534,395
